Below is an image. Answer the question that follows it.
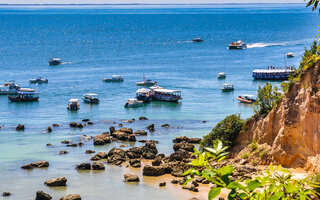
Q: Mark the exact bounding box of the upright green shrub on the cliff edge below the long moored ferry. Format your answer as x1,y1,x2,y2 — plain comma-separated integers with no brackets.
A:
253,83,282,115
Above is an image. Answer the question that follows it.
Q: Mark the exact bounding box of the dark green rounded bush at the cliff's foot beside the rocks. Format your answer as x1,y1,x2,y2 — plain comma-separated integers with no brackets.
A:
201,114,246,147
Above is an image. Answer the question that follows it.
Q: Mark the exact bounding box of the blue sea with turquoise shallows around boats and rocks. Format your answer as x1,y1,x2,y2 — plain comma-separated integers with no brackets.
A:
0,4,319,200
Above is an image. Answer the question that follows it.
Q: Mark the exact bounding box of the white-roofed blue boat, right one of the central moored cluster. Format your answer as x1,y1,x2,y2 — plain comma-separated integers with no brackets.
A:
150,87,182,102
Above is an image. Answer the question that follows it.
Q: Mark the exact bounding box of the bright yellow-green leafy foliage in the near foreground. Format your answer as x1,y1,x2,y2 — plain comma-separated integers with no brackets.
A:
183,140,319,200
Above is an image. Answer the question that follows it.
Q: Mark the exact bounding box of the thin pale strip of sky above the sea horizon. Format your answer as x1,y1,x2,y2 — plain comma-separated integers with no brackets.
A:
0,0,304,4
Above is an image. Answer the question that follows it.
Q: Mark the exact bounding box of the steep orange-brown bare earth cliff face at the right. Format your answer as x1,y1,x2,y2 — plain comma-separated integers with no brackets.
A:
234,63,320,170
